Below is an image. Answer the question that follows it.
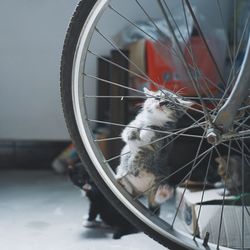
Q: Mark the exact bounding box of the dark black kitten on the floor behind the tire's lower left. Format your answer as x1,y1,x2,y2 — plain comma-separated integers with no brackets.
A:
69,163,138,239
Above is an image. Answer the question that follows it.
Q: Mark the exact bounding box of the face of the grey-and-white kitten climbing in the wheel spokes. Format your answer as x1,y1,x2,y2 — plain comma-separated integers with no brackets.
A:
143,88,193,121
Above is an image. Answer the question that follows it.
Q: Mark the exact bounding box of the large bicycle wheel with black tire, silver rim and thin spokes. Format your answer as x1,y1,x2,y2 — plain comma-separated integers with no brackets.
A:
61,0,250,249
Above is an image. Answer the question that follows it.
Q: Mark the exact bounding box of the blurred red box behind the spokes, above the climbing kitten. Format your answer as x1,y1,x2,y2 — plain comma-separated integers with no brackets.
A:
146,36,221,96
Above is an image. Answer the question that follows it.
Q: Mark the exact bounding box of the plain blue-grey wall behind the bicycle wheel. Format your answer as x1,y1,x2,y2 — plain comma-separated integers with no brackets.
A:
0,0,231,140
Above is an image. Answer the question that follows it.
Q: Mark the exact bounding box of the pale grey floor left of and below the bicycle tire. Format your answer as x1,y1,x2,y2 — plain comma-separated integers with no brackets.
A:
0,170,168,250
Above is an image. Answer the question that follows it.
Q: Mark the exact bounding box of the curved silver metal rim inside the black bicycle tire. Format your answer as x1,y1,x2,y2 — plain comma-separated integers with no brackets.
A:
72,0,250,249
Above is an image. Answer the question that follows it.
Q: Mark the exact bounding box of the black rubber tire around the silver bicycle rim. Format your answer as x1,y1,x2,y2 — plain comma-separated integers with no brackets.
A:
60,0,205,250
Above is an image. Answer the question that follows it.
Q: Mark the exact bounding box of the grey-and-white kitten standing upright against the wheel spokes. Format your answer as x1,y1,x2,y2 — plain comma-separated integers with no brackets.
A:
116,88,193,214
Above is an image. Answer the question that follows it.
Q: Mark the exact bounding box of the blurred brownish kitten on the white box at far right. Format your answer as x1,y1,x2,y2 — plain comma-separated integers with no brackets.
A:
215,155,250,195
